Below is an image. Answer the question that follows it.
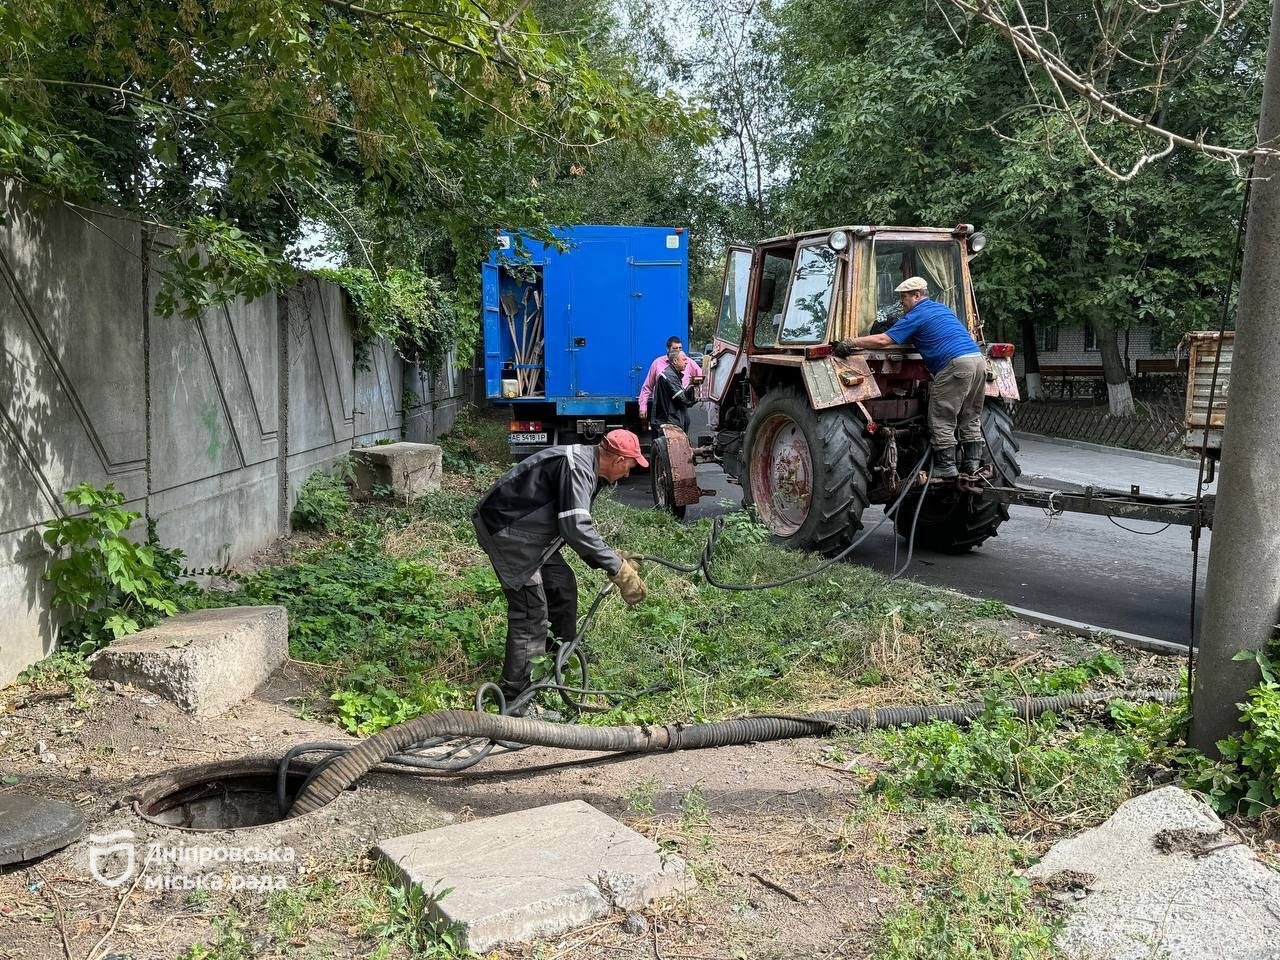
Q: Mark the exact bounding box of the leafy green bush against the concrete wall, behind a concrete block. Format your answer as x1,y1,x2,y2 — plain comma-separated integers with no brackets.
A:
45,484,193,655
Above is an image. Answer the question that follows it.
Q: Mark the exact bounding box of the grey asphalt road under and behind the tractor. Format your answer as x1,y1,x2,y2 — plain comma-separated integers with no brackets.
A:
617,407,1212,644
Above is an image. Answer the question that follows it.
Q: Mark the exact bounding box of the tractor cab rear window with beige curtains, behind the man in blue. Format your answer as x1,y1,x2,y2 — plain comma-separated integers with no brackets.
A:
858,237,969,335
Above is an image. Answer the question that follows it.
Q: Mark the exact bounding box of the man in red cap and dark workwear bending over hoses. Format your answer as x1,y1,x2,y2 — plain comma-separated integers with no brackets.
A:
471,430,649,713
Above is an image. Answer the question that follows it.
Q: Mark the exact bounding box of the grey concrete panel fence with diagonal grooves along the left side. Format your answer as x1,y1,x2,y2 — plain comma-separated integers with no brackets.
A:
0,183,463,684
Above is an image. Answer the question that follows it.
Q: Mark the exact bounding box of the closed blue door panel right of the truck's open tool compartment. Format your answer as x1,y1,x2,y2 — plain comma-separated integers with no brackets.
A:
567,239,631,397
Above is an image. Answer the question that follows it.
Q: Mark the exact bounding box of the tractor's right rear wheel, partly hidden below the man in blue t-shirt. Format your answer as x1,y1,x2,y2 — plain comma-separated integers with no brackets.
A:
893,399,1023,553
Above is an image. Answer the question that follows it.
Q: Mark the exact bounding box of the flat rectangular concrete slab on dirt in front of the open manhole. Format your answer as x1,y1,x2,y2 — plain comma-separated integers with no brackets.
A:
376,800,694,952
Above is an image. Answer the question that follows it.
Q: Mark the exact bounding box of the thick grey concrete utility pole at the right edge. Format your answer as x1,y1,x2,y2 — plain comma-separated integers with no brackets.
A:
1190,0,1280,756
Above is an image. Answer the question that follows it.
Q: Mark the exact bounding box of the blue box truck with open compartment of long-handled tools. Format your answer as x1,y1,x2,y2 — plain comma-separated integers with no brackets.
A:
481,225,689,457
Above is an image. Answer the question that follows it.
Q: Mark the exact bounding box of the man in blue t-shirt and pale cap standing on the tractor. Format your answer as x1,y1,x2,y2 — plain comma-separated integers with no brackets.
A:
836,276,987,480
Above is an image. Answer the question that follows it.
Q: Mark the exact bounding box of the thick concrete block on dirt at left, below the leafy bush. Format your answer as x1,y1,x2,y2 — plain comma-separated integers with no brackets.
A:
92,607,289,717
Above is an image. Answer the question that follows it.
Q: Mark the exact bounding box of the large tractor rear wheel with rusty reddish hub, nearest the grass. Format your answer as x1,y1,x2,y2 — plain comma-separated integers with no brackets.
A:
742,387,872,554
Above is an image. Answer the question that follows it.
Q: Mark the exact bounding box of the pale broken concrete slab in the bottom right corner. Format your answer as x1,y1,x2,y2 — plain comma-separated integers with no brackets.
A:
1027,787,1280,960
